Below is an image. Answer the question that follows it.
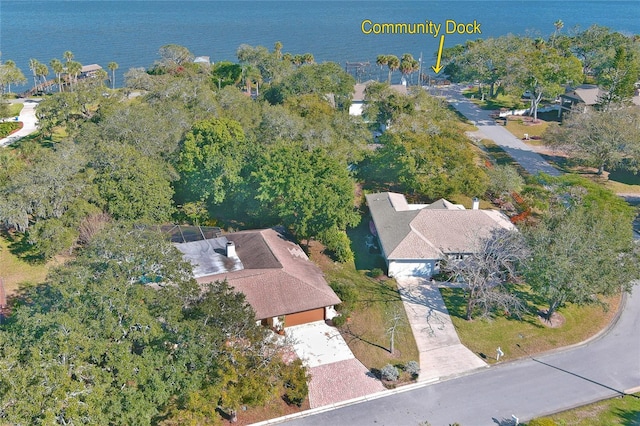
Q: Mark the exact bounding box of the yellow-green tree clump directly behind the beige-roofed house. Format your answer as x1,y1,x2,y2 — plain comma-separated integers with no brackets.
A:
361,85,487,199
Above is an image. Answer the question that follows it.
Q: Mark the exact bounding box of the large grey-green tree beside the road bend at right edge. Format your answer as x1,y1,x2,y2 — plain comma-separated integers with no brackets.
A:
525,176,640,317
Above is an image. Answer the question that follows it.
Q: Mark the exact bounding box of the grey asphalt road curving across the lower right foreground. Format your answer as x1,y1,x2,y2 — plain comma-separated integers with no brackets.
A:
287,285,640,426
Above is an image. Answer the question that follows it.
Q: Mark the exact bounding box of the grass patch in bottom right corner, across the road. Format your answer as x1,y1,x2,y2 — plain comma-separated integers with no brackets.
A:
529,393,640,426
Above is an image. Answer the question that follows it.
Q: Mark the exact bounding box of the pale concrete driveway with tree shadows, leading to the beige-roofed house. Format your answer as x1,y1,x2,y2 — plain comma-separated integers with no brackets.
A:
396,277,488,381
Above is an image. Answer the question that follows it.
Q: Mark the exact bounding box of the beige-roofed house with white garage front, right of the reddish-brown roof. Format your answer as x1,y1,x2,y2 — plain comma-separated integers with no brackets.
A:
366,192,514,277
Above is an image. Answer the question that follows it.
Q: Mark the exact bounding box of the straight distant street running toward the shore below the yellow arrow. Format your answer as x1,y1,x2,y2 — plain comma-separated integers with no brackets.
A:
434,85,561,176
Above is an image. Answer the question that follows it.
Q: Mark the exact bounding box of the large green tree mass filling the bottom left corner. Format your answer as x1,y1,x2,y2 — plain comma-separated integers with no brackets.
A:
0,227,306,424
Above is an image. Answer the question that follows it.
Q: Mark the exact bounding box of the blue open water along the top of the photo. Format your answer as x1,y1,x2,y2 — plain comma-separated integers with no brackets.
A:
0,0,640,89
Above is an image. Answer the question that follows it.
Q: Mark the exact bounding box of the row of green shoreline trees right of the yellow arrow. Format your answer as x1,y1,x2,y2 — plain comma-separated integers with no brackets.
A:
443,27,640,116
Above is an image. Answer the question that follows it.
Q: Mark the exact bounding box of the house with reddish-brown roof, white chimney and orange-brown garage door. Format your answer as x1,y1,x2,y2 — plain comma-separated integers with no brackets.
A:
175,229,341,327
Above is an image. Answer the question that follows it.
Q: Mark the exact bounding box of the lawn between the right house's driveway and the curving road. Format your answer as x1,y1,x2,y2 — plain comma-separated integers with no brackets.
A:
441,287,620,363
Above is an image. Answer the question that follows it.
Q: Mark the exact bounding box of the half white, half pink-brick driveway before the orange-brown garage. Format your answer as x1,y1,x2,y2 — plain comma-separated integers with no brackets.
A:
285,322,385,408
